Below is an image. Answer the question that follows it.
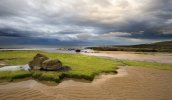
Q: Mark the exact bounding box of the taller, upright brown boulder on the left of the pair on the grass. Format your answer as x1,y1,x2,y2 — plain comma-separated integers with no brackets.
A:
29,54,49,70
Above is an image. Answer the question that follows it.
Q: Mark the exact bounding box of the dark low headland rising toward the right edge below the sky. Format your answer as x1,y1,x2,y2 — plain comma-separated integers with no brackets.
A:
87,41,172,52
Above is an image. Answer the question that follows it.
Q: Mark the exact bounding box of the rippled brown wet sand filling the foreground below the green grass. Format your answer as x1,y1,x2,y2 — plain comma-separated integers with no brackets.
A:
0,67,172,100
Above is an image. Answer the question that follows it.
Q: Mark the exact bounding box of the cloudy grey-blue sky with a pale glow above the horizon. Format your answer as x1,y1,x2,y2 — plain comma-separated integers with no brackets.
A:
0,0,172,47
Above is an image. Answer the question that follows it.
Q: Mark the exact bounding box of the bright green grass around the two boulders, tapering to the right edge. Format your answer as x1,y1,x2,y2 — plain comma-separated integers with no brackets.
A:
0,51,172,83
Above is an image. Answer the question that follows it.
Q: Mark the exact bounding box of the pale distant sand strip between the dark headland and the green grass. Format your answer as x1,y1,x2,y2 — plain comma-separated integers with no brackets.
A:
83,51,172,63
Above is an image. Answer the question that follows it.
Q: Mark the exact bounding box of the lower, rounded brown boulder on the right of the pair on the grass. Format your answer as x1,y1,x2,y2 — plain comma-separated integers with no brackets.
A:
42,59,62,71
